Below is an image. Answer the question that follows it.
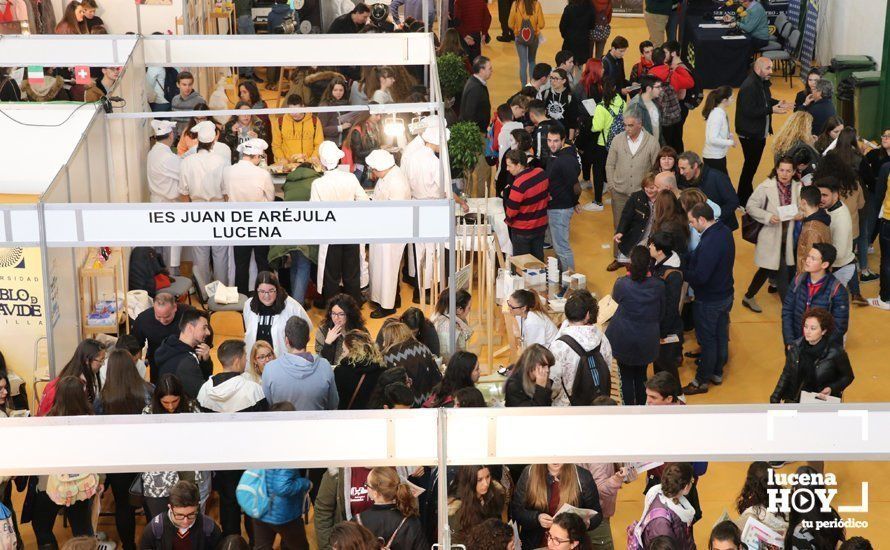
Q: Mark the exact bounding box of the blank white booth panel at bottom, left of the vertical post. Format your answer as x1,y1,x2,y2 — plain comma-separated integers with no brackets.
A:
0,410,437,475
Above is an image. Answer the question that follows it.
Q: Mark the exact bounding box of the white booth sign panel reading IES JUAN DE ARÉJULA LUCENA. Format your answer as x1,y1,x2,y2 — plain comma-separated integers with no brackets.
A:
46,201,449,247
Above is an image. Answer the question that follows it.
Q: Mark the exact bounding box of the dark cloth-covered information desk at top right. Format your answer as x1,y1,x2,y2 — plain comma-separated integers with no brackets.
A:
682,15,751,90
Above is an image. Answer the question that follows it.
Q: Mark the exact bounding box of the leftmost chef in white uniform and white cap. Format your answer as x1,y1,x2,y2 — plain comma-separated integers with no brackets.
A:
146,120,182,275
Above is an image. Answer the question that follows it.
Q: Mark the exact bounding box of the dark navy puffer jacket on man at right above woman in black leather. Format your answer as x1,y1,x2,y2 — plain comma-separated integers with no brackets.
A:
782,273,850,346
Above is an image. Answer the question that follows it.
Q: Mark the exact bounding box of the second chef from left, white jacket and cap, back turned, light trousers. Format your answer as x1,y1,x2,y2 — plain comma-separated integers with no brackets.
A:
179,120,229,289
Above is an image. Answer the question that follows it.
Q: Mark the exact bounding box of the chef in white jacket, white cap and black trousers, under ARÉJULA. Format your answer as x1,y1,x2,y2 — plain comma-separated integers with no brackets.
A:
309,141,370,305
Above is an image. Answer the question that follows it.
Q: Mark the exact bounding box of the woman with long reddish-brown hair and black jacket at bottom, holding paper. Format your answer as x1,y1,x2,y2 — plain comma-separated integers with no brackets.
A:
511,464,603,548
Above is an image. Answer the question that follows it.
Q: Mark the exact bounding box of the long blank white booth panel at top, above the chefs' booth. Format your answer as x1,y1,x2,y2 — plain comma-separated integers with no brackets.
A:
143,33,433,67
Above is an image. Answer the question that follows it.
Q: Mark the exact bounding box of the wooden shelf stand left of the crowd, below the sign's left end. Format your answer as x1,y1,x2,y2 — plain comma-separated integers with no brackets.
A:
80,248,130,338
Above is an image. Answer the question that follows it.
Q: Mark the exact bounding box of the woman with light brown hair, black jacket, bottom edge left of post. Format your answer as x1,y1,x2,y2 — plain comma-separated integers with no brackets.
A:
355,467,430,550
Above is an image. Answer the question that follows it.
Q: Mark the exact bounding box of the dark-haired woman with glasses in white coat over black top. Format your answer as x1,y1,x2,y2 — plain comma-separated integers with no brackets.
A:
244,271,312,362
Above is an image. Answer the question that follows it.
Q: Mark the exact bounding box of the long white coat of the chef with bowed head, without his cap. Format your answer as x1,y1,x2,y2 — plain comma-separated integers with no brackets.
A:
370,166,411,309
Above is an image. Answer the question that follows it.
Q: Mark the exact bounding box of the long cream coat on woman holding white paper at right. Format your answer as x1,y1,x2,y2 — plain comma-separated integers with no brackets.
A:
745,178,800,270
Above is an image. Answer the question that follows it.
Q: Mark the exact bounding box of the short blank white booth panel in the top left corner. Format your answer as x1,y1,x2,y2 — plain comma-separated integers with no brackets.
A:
0,34,139,67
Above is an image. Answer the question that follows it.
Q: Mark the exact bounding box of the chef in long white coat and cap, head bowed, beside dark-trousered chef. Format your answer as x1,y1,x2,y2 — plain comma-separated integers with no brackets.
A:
365,149,411,319
